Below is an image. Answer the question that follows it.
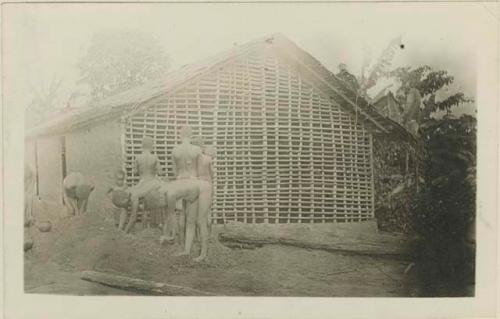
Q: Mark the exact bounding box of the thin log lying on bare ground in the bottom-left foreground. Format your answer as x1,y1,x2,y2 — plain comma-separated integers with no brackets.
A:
80,271,214,296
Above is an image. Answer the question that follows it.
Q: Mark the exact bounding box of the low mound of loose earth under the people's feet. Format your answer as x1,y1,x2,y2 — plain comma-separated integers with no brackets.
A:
29,212,238,280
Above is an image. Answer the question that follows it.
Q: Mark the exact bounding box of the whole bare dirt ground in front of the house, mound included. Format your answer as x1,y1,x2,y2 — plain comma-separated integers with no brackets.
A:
24,204,408,297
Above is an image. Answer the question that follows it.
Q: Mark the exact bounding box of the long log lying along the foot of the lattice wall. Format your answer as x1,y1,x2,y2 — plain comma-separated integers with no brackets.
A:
219,225,410,260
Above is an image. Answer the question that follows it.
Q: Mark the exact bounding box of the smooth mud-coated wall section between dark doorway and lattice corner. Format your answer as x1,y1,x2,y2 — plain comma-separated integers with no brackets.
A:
66,119,122,213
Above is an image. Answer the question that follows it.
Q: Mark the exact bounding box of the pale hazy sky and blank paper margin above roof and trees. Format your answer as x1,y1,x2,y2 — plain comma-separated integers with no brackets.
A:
3,3,488,117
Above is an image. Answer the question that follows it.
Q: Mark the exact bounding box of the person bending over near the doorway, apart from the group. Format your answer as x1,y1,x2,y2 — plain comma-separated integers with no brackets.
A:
63,173,94,216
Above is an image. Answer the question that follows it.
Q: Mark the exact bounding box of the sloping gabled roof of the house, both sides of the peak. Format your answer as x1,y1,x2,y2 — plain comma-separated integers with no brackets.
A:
26,34,414,144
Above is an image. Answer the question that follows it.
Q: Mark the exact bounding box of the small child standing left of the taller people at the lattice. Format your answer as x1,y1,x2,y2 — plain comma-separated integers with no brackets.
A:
108,170,130,230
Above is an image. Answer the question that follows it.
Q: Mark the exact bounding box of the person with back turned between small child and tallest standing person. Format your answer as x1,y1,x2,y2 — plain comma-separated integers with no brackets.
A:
125,136,162,233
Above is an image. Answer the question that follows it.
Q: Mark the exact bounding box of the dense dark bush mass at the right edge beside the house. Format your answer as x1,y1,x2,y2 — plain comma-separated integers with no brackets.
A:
409,115,476,296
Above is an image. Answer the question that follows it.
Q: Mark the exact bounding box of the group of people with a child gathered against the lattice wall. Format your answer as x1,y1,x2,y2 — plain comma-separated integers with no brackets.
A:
108,127,214,261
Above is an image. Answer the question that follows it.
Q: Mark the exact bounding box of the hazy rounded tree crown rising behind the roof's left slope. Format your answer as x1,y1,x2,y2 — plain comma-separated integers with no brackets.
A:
78,30,169,100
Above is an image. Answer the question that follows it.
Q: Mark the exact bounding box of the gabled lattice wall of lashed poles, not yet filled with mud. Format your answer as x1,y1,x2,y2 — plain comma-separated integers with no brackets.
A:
124,48,374,223
